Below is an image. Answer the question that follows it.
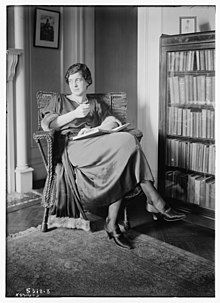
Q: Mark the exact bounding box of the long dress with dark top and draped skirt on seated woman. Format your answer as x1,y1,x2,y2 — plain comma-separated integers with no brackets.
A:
42,94,154,216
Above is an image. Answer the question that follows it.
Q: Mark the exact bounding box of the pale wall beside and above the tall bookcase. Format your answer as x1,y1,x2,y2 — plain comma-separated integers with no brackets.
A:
138,6,215,188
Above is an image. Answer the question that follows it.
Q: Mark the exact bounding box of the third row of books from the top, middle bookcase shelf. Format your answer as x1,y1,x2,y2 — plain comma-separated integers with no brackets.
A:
168,106,215,139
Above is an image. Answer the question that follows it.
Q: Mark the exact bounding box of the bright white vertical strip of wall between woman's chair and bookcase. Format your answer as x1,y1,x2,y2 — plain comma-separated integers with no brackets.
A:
137,8,161,185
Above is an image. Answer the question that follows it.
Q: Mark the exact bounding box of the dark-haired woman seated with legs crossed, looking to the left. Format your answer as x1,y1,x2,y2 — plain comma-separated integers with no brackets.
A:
42,63,185,248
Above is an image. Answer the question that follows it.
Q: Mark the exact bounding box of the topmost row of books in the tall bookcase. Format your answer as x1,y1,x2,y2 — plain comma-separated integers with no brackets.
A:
167,49,215,72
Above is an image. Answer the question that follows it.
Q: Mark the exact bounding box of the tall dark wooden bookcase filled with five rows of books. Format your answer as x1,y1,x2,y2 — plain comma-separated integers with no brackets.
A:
158,31,215,228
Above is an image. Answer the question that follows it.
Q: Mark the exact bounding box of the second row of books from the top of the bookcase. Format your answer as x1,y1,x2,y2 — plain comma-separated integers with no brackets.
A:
167,75,215,104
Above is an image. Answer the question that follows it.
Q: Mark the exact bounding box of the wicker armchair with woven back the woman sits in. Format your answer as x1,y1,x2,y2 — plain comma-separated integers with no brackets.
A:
33,91,143,232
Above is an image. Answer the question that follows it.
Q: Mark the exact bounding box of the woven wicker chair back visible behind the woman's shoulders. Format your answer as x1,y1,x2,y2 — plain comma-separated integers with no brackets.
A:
36,91,127,130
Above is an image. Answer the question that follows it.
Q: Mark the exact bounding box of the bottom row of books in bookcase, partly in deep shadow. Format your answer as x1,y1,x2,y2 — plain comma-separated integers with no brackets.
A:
165,170,215,209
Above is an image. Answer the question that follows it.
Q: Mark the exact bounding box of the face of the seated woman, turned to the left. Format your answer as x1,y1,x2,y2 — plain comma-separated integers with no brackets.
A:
68,72,88,96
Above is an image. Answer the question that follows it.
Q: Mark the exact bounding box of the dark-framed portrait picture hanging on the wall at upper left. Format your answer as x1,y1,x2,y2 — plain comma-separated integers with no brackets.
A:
34,8,60,49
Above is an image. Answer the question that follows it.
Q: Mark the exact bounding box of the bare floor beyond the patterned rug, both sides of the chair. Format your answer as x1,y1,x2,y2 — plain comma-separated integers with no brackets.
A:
6,197,215,261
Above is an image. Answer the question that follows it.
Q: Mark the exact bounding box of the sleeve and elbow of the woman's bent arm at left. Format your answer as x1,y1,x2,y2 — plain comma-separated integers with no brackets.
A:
41,95,61,131
